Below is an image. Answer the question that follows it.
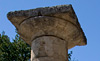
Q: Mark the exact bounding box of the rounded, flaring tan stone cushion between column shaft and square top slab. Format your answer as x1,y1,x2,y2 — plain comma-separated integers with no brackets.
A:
18,16,82,48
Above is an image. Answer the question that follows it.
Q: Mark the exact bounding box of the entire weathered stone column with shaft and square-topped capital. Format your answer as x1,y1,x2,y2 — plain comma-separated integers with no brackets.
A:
7,5,87,61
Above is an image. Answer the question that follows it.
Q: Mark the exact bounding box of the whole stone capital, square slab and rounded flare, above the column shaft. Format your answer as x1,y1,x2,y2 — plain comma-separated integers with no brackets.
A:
7,5,86,49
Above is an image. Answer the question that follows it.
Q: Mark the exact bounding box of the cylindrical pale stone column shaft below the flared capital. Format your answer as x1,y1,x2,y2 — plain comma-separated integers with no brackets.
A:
31,36,68,61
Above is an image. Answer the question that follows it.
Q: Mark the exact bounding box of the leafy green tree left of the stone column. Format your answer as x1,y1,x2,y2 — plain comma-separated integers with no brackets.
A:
0,32,31,61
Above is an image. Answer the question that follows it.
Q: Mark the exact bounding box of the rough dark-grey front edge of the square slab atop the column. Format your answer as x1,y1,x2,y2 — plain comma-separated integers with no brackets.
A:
7,5,72,19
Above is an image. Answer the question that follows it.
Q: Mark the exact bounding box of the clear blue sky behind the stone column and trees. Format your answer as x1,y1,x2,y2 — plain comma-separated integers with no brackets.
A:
0,0,100,61
